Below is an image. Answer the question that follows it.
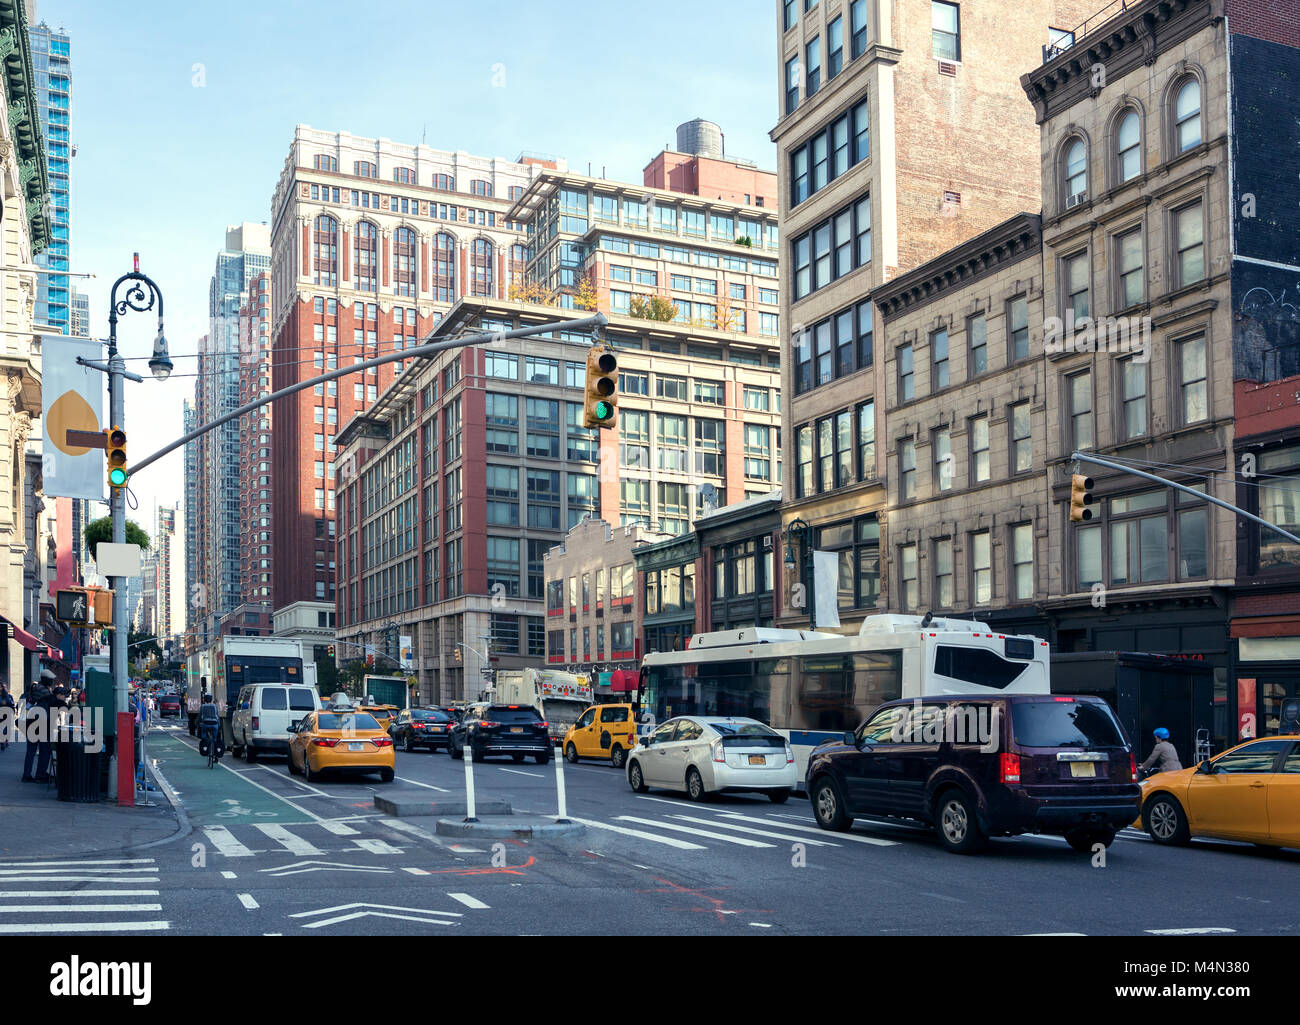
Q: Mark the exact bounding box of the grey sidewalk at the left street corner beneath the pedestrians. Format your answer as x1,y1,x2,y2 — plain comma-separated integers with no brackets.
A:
0,743,178,860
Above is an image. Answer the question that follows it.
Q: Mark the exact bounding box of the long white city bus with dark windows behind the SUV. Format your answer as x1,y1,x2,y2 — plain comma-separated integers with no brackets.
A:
638,615,1052,779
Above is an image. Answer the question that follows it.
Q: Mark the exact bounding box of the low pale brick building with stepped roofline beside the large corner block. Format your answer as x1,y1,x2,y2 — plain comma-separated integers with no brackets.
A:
542,516,667,695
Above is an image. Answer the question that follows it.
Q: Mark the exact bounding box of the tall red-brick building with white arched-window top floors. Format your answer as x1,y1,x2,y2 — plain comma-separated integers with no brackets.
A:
270,125,563,632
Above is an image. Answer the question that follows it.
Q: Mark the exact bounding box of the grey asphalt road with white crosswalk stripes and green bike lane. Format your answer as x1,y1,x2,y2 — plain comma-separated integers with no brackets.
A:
0,725,1300,935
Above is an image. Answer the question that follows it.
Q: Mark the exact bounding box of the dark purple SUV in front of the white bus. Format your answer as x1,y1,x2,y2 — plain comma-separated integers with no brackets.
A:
806,695,1140,853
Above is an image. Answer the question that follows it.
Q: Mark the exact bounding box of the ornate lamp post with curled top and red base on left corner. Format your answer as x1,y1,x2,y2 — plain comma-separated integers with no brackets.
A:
77,252,172,805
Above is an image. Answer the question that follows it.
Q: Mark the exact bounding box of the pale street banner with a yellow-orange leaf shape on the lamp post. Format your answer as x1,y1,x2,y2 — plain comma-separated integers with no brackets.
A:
40,334,107,502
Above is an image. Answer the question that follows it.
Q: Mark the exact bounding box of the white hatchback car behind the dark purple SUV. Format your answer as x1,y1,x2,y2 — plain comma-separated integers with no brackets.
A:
627,715,798,804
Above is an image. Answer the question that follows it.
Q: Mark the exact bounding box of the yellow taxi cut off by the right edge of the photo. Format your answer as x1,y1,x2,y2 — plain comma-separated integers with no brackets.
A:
1141,735,1300,847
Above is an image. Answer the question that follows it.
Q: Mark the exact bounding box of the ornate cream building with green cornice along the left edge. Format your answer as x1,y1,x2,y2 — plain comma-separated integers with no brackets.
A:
0,3,52,693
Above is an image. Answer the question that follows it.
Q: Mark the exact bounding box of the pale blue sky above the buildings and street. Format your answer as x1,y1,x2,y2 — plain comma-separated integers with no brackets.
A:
48,0,777,523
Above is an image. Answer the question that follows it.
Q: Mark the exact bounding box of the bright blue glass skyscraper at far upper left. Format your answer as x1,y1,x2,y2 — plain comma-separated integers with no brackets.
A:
27,4,73,334
